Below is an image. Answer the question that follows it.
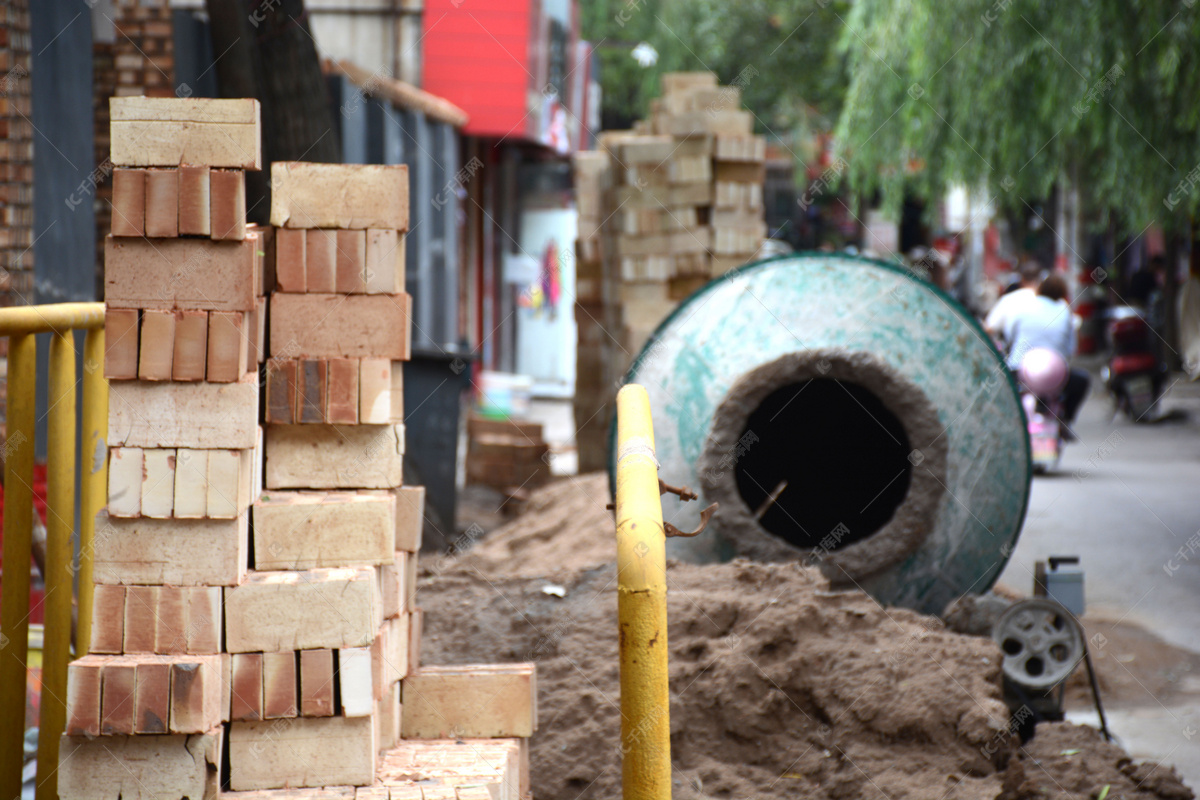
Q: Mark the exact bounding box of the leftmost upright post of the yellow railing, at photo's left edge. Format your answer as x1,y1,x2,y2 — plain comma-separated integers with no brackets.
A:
0,333,37,798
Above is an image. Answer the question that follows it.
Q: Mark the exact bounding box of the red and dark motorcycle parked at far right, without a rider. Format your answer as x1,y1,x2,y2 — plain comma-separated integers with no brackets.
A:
1100,306,1166,422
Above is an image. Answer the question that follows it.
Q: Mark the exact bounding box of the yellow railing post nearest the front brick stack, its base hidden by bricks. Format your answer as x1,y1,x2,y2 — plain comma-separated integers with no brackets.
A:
76,327,108,655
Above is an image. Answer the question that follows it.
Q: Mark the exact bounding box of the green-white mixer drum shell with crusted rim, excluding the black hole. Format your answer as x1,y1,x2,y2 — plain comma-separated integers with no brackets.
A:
610,253,1032,613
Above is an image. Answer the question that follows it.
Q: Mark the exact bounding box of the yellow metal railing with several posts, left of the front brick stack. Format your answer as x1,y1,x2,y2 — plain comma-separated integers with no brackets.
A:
0,302,108,800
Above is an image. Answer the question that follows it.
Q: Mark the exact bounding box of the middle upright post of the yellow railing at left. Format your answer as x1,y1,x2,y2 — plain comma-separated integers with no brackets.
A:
35,330,76,800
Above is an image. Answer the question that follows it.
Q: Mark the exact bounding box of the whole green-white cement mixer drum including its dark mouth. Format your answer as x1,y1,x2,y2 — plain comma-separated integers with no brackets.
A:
628,254,1031,613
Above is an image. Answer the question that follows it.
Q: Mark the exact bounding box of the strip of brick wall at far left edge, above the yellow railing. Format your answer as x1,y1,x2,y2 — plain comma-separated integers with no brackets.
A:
0,0,34,311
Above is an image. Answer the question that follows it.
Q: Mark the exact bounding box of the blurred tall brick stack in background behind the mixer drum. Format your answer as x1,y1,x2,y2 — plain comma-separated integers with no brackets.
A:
575,72,767,471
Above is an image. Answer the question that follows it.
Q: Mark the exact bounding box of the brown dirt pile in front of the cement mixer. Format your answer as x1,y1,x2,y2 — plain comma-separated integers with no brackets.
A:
418,556,1193,800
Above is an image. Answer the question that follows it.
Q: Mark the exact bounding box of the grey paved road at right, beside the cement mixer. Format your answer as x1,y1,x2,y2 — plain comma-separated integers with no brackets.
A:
1001,367,1200,788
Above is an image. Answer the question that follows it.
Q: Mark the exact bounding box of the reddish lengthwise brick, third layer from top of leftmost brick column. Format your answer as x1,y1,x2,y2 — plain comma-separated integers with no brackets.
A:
104,231,263,311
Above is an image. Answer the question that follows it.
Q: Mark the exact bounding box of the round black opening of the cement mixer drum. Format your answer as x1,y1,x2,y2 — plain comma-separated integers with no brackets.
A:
734,378,912,549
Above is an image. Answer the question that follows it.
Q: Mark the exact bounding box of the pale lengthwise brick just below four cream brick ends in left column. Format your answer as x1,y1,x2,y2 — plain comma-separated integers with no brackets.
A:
95,512,250,585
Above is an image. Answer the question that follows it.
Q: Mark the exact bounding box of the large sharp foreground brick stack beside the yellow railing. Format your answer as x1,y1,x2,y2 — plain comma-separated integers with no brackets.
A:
59,98,535,800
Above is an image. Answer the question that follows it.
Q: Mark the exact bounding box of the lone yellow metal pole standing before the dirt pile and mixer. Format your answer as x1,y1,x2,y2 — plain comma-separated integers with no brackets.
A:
617,384,671,800
